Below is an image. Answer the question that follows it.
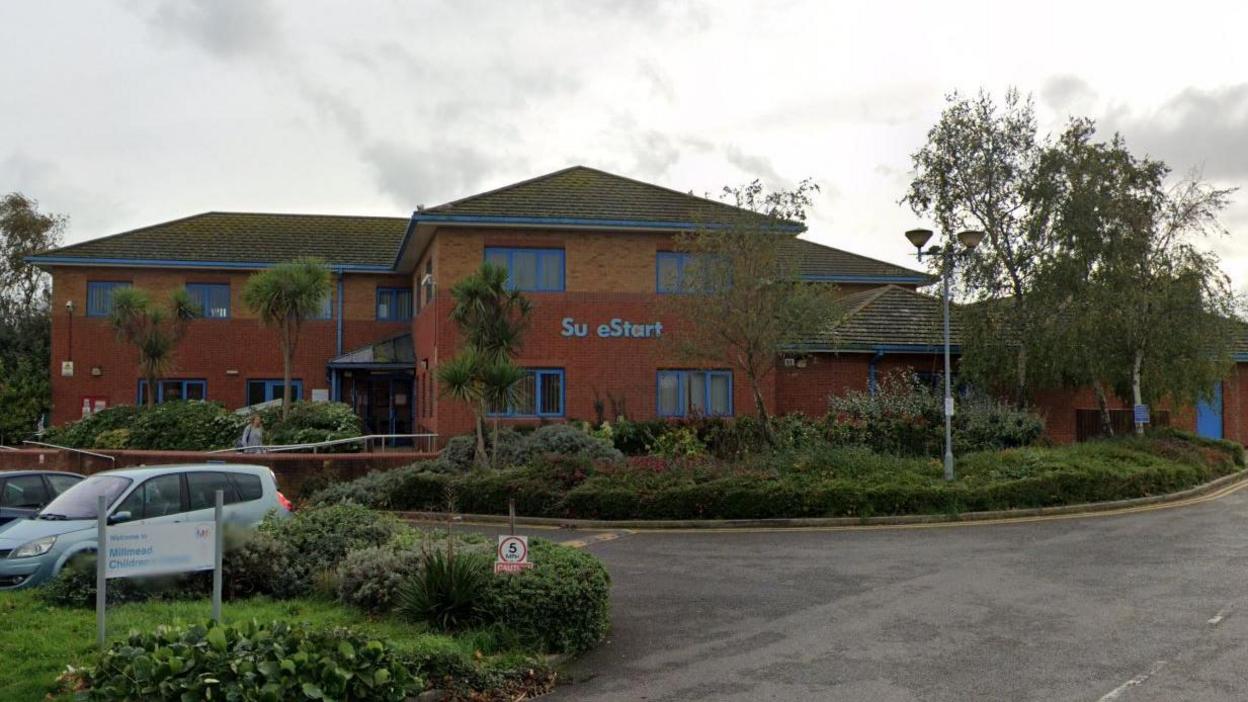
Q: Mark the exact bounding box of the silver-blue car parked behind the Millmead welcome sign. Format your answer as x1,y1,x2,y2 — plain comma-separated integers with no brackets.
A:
0,463,291,590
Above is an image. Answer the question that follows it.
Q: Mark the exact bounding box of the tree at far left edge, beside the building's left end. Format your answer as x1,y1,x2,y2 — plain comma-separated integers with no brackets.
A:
0,192,66,432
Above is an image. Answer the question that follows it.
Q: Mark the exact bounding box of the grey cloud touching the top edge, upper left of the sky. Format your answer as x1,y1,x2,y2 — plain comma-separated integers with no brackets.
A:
147,0,281,59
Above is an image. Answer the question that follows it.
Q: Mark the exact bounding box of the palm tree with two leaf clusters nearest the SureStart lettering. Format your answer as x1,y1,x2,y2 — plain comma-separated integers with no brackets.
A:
437,262,533,467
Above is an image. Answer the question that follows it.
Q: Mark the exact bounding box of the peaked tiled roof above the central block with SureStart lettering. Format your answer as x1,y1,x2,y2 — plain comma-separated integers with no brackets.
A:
416,166,804,231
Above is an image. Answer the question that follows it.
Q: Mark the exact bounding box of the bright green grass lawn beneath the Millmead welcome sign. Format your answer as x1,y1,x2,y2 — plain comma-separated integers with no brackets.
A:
0,591,533,702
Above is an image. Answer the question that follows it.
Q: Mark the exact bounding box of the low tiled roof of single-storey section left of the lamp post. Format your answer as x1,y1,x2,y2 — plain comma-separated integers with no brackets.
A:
807,285,962,351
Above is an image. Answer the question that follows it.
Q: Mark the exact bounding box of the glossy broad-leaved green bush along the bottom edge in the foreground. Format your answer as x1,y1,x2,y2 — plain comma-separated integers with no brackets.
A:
80,622,423,702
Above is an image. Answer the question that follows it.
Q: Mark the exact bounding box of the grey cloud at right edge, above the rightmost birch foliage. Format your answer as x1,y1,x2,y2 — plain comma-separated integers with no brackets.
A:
1102,82,1248,179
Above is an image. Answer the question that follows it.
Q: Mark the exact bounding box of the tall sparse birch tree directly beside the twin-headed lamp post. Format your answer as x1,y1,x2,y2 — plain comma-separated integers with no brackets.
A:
902,90,1055,406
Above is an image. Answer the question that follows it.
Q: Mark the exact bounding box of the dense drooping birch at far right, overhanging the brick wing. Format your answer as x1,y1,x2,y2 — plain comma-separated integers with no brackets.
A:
1032,120,1237,433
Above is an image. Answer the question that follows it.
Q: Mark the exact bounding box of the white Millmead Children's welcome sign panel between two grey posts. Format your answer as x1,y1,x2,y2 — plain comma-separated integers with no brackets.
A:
105,522,216,578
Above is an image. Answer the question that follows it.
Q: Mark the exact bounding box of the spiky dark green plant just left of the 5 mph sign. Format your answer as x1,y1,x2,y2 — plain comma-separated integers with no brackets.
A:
397,550,490,631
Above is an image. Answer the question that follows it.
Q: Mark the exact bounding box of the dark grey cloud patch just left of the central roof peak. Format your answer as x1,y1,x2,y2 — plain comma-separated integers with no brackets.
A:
361,140,503,207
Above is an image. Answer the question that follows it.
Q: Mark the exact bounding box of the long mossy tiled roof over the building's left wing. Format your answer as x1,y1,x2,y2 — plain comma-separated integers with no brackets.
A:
34,212,408,270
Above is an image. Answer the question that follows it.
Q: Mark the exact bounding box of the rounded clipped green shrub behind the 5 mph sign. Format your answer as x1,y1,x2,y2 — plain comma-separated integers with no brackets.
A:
480,538,612,653
